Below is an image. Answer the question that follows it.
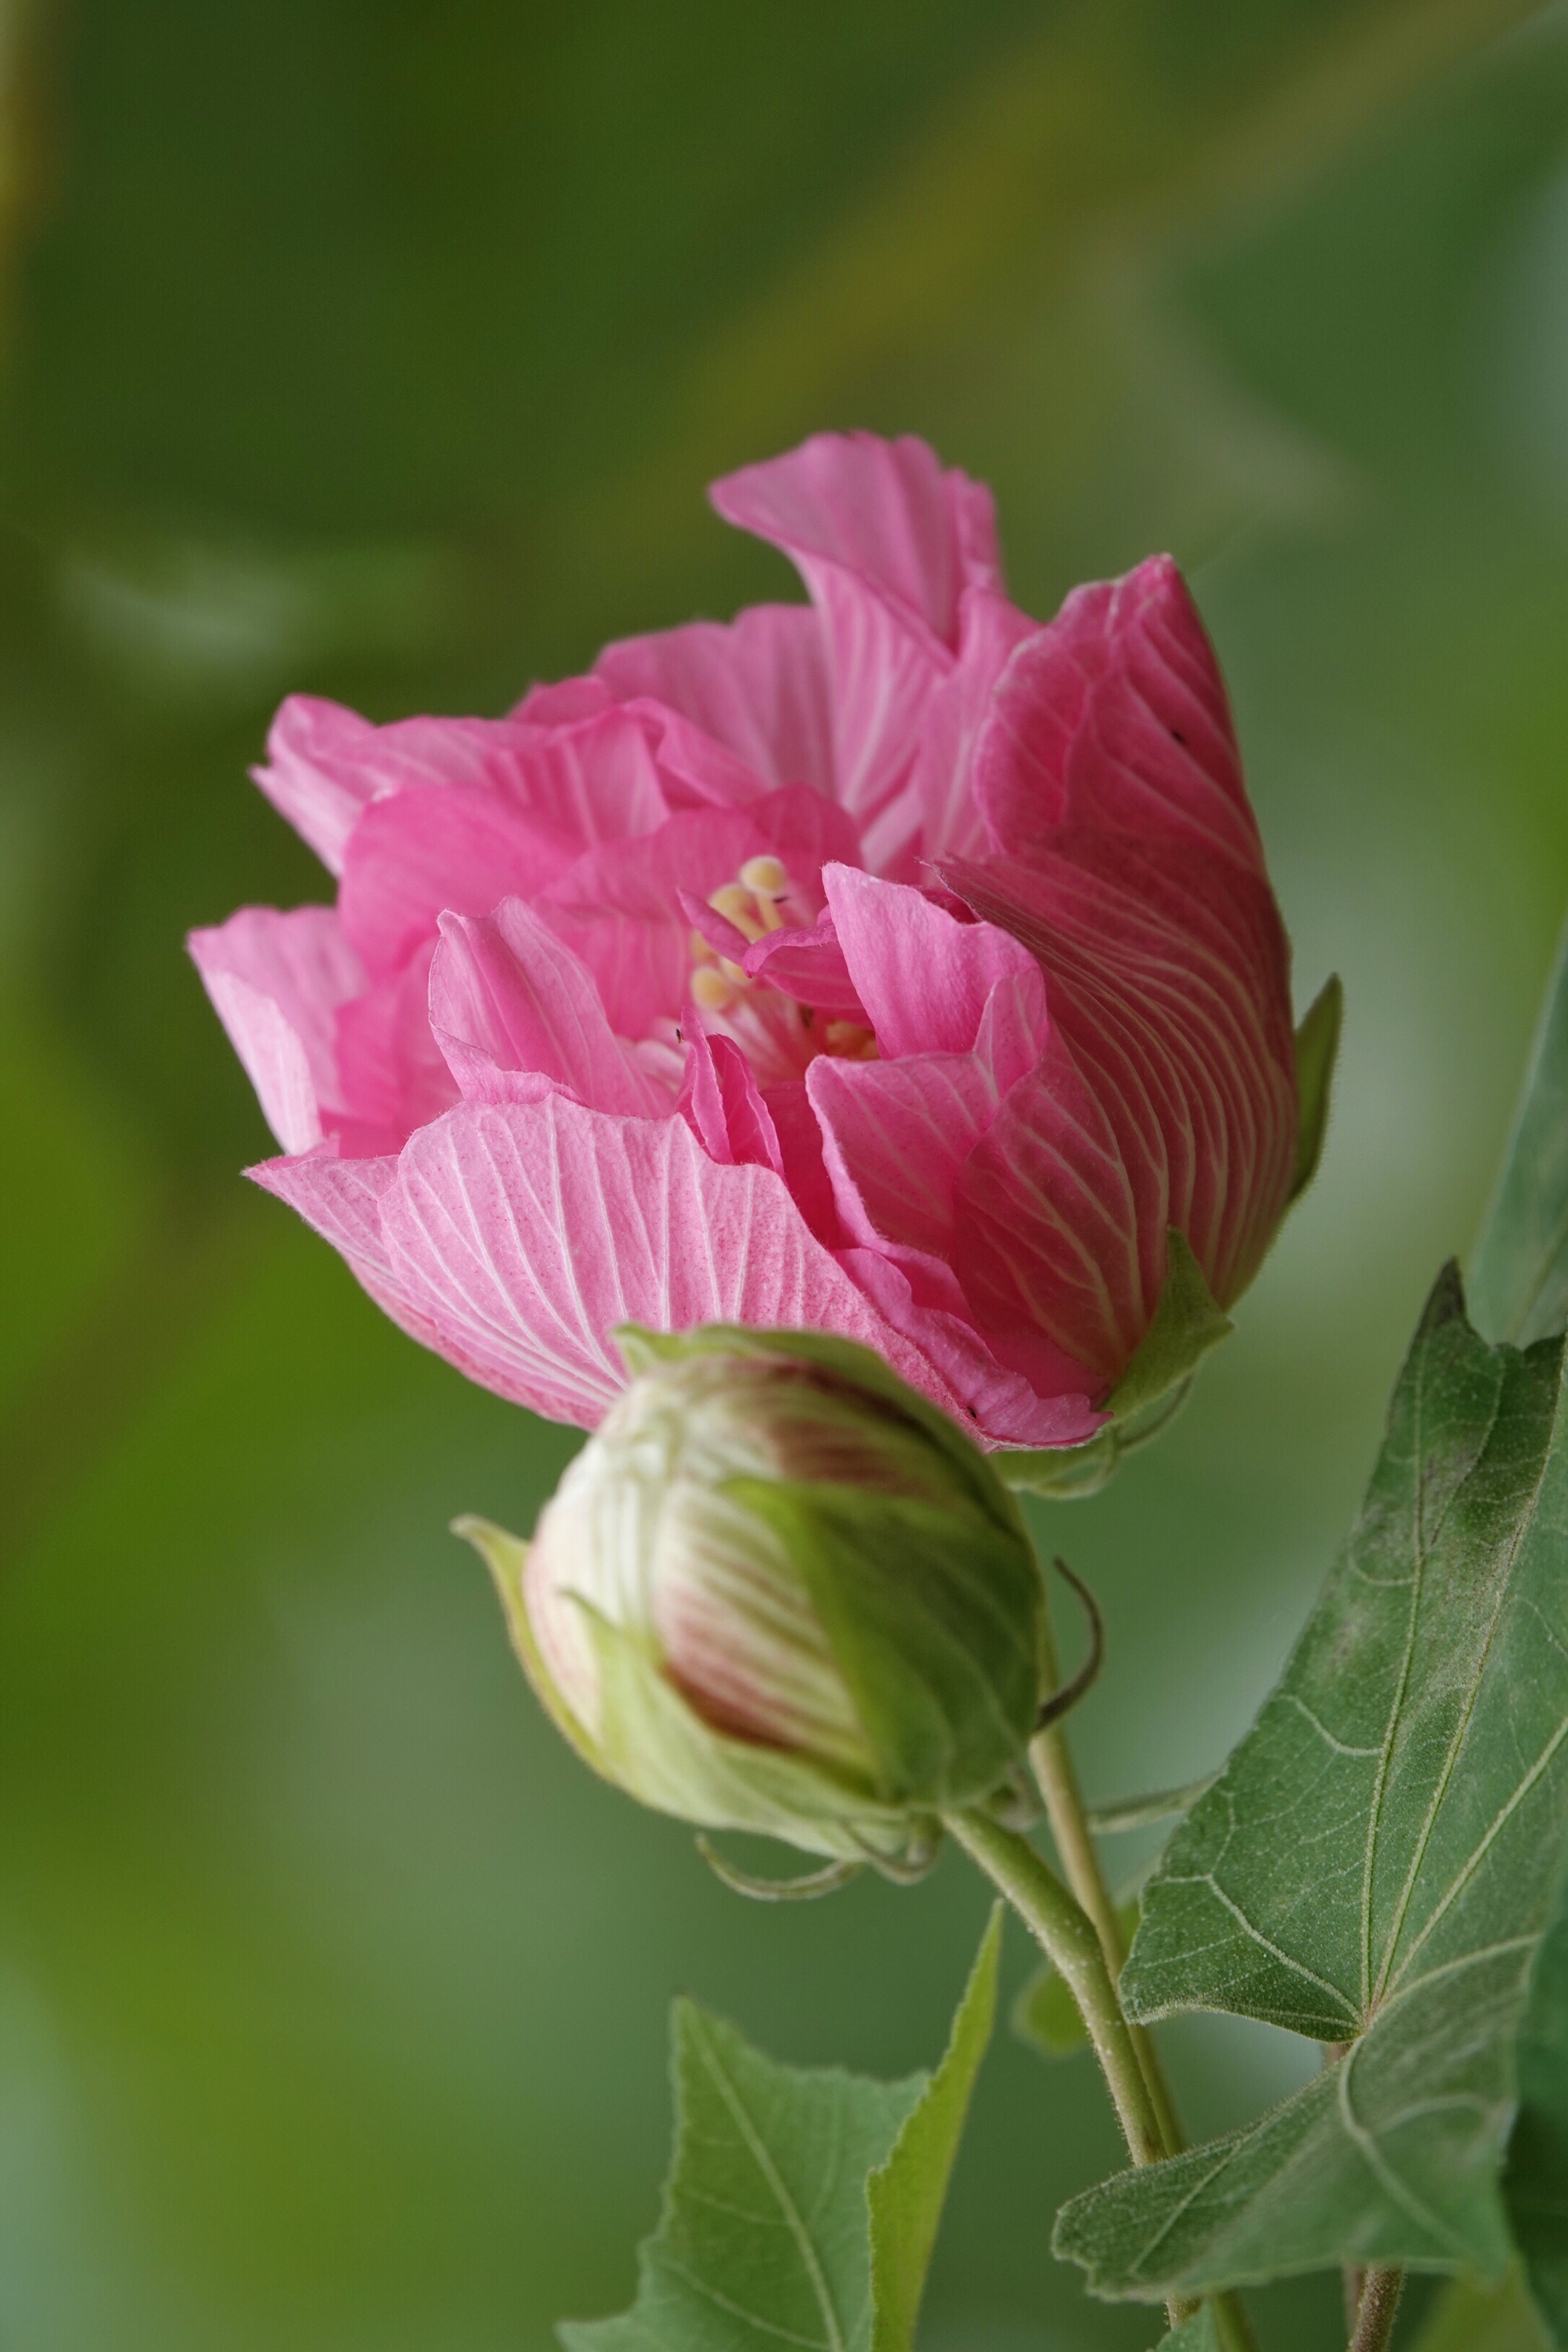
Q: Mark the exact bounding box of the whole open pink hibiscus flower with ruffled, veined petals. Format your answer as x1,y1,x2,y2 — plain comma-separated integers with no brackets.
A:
190,435,1298,1447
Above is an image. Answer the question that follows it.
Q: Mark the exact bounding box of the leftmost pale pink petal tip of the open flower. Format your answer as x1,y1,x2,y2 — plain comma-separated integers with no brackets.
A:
188,905,364,1153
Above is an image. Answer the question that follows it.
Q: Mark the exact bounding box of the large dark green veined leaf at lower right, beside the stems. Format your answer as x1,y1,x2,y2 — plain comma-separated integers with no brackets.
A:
1058,1270,1568,2298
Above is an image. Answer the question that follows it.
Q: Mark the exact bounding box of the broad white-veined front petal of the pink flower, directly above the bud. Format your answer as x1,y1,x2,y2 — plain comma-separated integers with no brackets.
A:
252,1094,961,1428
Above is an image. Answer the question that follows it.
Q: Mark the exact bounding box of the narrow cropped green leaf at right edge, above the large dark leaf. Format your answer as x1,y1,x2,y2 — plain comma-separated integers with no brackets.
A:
1469,931,1568,1348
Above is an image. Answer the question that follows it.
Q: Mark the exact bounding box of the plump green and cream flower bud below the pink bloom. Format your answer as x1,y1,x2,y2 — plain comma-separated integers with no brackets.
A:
461,1326,1042,1858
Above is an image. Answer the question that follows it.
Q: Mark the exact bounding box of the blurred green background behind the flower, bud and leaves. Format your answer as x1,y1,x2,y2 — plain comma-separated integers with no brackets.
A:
0,0,1568,2352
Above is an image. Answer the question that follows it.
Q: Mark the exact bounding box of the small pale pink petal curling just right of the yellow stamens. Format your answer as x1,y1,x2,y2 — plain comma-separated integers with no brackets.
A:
822,865,1032,1058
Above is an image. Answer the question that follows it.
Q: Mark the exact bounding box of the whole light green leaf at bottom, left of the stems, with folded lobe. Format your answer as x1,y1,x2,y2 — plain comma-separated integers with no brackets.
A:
560,1905,1002,2352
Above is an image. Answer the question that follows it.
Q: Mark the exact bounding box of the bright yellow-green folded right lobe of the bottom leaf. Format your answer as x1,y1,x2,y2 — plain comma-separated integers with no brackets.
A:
865,1903,1002,2352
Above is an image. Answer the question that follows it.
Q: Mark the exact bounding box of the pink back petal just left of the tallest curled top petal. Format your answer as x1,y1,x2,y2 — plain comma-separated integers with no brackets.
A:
595,605,835,795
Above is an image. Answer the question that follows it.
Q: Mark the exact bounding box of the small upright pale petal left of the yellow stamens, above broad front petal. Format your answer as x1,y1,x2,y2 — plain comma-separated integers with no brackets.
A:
430,899,670,1119
